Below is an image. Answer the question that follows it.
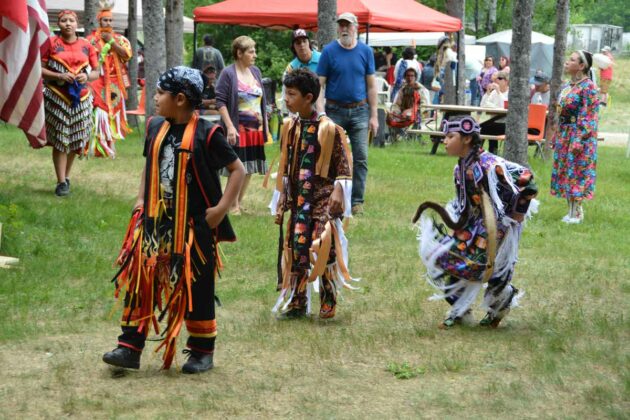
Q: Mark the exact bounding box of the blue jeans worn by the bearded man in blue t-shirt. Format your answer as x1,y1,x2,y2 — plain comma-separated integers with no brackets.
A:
326,103,370,206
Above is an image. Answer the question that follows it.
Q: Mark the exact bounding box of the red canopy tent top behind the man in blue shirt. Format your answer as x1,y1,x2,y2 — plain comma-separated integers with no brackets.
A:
193,0,462,32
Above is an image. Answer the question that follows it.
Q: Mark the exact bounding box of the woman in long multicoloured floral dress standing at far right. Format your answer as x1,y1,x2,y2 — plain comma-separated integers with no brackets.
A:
551,50,599,223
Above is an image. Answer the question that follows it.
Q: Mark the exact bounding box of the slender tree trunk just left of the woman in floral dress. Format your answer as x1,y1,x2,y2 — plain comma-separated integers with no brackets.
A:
544,0,570,157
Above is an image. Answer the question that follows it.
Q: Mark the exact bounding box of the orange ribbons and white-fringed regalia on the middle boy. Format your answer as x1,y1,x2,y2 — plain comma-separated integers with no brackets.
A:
269,117,360,314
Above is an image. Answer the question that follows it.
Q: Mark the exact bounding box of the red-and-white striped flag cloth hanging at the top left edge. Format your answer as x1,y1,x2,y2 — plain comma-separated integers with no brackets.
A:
0,0,50,148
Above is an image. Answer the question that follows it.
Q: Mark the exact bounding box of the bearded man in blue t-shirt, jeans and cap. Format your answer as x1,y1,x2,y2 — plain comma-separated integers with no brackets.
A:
317,12,378,215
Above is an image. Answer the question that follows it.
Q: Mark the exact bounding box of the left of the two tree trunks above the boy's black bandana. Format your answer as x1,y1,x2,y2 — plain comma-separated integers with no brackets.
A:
142,0,166,116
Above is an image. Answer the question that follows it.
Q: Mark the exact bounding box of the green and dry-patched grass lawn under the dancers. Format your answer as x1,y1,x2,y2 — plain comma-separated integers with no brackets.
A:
0,126,630,418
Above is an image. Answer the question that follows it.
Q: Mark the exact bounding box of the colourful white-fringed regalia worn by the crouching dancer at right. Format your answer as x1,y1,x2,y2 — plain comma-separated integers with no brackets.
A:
418,152,538,316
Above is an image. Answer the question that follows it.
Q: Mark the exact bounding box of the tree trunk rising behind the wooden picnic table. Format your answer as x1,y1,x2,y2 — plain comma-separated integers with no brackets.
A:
444,0,466,105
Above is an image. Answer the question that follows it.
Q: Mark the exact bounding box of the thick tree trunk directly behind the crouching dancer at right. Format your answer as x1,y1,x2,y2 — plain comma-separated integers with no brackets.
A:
504,0,534,165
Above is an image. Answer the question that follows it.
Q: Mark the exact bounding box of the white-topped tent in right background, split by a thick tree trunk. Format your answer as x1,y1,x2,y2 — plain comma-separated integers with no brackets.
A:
477,29,555,76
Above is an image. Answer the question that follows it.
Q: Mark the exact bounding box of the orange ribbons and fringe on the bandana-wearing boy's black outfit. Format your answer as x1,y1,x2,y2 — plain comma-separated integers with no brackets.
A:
114,115,221,369
